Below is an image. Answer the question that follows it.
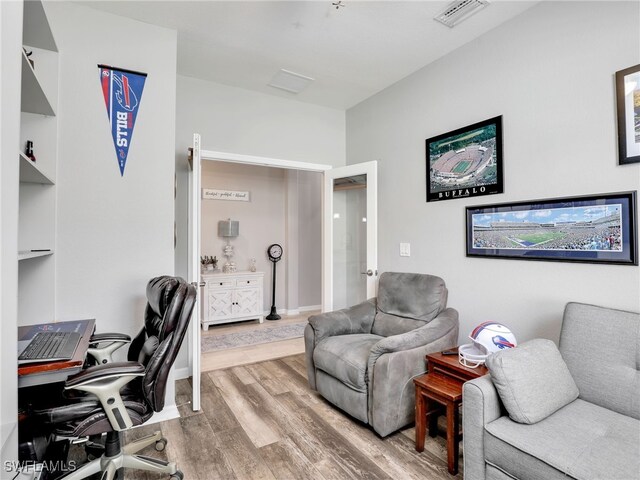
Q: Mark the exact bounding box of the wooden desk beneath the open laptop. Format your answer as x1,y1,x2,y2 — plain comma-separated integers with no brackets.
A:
18,319,96,388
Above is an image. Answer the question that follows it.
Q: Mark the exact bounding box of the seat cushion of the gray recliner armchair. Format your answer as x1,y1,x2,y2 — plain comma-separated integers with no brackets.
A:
313,333,383,392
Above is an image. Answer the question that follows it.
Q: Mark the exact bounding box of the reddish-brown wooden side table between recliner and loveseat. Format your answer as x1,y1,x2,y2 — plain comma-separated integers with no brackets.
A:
413,348,489,475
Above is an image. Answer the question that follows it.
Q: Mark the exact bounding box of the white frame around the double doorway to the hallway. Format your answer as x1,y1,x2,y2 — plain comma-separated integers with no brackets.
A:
188,133,337,411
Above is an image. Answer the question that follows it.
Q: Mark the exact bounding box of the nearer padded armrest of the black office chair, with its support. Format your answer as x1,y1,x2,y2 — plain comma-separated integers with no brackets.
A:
64,362,145,431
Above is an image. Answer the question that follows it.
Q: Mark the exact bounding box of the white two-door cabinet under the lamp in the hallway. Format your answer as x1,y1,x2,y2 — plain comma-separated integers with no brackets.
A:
201,272,264,330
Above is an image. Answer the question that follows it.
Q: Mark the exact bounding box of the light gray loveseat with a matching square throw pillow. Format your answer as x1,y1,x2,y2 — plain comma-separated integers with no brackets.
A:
463,303,640,480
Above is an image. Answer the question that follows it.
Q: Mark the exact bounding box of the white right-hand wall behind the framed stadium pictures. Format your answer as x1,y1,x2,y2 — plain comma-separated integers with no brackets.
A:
347,2,640,343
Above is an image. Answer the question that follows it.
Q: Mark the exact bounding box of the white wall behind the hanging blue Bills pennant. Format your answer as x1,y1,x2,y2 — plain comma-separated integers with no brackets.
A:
48,2,176,404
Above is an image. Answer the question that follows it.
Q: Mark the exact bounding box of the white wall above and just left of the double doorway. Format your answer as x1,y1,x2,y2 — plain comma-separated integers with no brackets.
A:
175,76,346,371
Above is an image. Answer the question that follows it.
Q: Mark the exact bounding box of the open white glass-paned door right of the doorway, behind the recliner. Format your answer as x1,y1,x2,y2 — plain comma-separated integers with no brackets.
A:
322,161,378,312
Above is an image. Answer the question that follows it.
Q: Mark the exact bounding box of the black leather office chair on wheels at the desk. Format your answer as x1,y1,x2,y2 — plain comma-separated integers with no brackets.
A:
35,276,196,480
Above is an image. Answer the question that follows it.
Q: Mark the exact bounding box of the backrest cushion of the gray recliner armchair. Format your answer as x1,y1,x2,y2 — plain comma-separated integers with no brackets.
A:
371,272,447,337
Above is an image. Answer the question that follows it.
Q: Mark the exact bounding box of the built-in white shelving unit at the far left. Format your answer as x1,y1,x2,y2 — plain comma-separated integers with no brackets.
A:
17,0,58,325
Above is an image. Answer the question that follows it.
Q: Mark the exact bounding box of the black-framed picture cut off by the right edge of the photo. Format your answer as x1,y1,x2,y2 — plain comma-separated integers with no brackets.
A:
616,64,640,165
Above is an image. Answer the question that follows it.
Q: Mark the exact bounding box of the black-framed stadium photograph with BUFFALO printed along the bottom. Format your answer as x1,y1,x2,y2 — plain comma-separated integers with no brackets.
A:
426,116,503,202
